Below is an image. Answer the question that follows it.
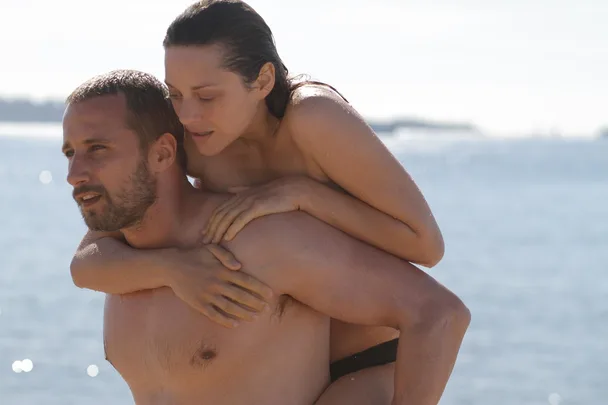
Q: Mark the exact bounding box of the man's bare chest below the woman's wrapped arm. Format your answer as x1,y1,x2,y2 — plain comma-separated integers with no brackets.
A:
104,193,329,405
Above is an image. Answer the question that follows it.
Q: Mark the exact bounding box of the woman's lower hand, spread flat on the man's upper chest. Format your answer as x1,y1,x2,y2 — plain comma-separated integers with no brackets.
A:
164,241,273,328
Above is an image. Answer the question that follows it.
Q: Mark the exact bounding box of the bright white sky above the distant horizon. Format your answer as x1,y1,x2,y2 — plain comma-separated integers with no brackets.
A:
0,0,608,135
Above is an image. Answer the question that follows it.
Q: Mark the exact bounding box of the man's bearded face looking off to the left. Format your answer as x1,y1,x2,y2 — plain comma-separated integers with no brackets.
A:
63,95,156,232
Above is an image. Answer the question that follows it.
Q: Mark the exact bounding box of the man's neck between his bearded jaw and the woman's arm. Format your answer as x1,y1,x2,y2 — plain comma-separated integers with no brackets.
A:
122,177,197,249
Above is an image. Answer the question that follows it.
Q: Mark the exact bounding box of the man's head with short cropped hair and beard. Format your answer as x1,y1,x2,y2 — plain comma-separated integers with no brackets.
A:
63,70,186,231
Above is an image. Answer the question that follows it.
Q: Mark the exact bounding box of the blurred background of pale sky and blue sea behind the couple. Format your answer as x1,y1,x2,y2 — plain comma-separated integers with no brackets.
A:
0,0,608,405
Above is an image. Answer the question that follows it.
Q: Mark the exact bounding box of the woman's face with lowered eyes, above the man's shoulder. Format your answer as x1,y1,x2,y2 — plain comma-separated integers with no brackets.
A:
165,45,263,156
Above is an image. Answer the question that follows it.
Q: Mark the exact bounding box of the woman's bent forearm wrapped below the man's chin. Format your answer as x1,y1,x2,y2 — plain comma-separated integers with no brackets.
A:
70,237,173,294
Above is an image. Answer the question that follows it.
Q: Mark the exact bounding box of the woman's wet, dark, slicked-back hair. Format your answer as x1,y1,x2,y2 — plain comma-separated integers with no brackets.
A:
163,0,346,118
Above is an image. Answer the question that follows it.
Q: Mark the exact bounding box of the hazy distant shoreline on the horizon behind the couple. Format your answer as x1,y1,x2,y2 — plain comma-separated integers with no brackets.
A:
0,99,478,133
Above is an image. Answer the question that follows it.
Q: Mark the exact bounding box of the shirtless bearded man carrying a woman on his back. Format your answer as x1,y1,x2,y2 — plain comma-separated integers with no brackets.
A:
63,71,470,405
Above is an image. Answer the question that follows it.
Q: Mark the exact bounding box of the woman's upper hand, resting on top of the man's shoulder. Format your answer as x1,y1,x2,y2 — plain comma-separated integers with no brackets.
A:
203,177,314,243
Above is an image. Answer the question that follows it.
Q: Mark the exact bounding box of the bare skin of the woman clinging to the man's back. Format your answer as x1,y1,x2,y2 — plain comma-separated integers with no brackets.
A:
71,45,444,396
